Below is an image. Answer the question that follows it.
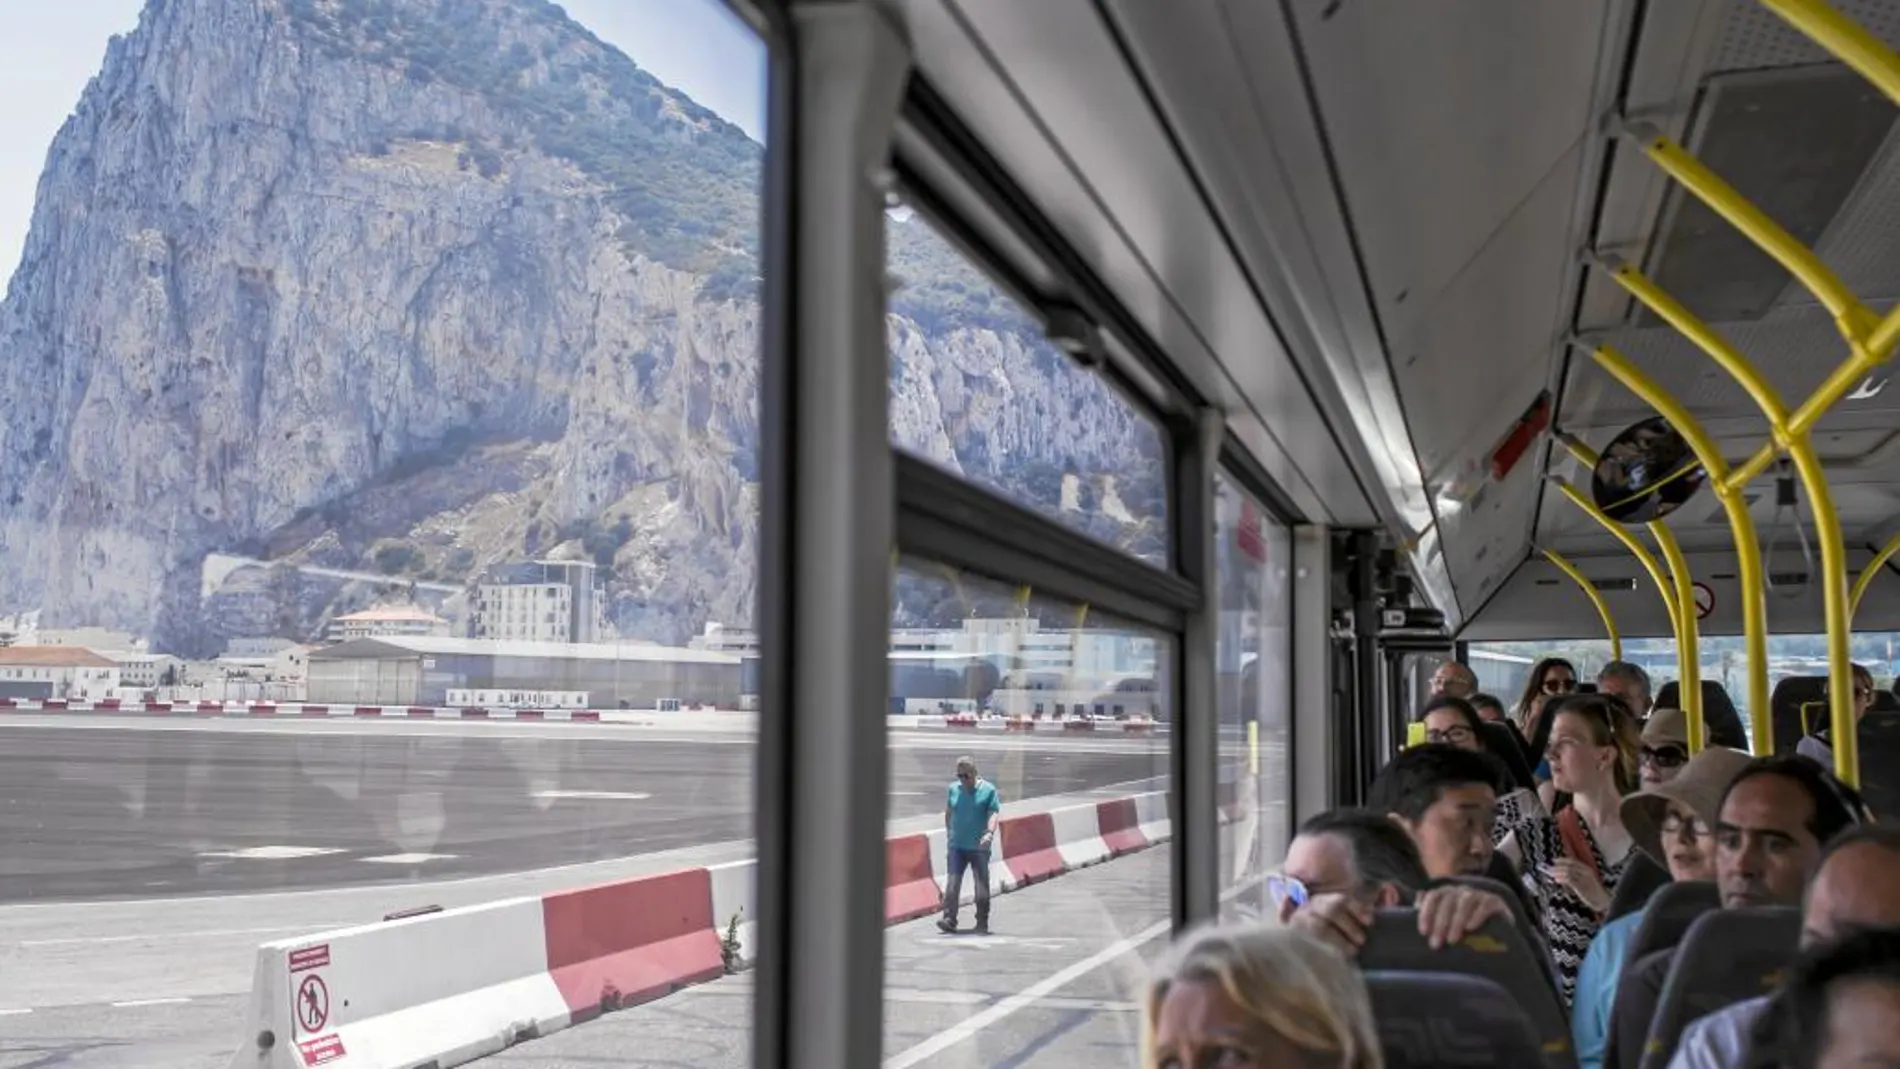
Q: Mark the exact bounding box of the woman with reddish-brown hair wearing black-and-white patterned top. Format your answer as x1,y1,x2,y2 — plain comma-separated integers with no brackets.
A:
1497,695,1636,1004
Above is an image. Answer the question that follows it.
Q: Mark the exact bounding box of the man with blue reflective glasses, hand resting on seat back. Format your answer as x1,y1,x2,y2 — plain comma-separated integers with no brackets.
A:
1267,809,1512,957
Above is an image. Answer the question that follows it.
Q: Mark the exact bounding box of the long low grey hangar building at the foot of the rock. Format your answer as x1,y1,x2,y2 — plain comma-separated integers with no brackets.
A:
308,636,739,708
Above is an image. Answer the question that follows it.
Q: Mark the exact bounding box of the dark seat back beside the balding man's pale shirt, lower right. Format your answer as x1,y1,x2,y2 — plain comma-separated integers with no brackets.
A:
1642,906,1801,1069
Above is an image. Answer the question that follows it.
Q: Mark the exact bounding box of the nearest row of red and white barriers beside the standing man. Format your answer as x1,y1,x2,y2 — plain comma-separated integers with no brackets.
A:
232,789,1169,1069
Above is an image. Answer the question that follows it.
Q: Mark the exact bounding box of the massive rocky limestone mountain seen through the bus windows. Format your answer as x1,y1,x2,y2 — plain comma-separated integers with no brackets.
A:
0,0,1161,653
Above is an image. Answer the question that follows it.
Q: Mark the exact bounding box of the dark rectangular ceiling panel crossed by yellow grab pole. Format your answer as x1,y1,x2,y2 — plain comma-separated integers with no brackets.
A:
1640,63,1896,327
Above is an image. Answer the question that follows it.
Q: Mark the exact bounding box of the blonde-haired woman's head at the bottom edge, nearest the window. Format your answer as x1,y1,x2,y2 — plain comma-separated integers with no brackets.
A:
1142,925,1385,1069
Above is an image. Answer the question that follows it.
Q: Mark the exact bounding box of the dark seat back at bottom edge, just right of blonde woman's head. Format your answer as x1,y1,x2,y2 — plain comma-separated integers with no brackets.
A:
1366,970,1541,1069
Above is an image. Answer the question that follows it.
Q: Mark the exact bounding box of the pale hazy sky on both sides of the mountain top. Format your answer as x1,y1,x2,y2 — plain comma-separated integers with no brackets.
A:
0,0,766,292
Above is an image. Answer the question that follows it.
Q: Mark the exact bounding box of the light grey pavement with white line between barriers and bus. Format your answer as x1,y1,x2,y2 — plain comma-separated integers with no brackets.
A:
477,845,1169,1069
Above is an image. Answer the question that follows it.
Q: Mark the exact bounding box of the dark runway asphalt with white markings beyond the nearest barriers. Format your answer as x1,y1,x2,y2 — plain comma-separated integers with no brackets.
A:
0,722,1167,904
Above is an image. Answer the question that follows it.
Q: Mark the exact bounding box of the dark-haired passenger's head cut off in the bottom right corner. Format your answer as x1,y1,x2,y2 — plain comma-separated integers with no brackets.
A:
1748,927,1900,1069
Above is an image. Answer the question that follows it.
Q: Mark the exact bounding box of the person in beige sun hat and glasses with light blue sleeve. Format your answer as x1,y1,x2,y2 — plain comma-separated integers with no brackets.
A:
1569,744,1750,1069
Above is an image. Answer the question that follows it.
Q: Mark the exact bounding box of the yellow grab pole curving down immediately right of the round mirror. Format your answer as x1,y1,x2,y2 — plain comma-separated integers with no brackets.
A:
1590,341,1780,754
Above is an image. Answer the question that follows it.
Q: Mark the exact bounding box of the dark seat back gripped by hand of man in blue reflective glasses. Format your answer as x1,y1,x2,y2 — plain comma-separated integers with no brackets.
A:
1359,910,1577,1069
